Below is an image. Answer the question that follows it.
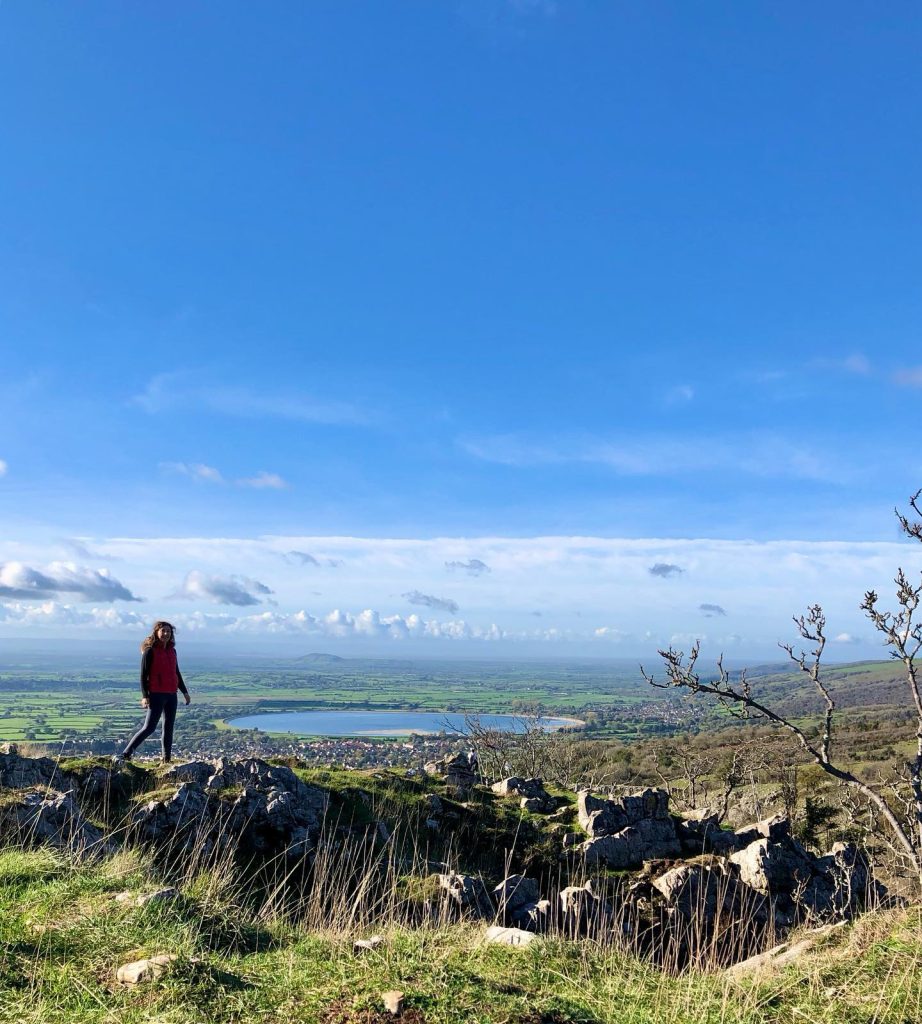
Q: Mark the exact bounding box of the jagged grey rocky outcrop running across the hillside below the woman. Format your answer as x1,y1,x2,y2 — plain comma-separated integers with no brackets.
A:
0,749,883,964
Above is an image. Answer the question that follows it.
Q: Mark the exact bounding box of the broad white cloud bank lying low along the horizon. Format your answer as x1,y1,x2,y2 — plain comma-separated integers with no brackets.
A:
0,537,922,658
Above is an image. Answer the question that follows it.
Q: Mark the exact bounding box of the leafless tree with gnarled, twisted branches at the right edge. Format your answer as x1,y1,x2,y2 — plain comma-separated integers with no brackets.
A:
640,489,922,888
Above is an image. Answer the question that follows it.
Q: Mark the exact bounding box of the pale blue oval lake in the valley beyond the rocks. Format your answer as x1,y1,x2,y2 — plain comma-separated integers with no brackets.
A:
227,711,582,736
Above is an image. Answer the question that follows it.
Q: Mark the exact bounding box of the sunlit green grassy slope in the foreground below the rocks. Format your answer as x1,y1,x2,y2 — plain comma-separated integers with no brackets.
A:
0,851,922,1024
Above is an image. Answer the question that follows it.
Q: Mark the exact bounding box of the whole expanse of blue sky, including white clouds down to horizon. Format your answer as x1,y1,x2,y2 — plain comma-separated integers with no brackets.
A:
0,0,922,655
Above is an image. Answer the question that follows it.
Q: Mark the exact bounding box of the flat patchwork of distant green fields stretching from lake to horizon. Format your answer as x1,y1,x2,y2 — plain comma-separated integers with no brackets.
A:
0,656,906,751
